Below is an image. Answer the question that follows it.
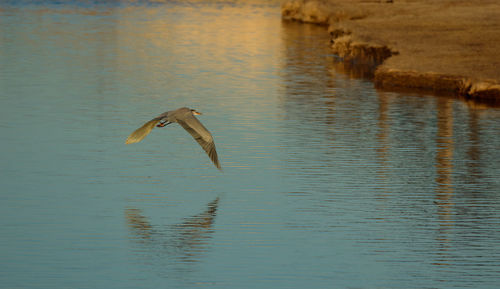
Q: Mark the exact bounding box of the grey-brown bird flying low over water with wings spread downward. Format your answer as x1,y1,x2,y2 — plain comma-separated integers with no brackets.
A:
125,107,222,170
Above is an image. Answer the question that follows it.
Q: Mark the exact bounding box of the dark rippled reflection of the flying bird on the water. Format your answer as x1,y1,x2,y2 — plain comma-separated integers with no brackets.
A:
125,197,219,261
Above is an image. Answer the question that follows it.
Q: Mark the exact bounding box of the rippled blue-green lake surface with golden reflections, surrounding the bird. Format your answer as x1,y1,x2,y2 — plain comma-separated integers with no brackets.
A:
0,1,500,288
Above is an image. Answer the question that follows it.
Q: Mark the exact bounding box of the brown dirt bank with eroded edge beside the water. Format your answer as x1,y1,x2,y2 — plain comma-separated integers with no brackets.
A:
282,0,500,102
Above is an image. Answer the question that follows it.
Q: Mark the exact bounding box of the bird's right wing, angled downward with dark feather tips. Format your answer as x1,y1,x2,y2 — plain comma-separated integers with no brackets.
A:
177,114,221,170
